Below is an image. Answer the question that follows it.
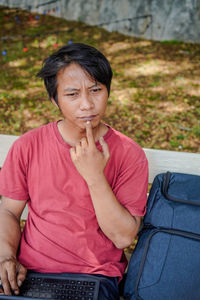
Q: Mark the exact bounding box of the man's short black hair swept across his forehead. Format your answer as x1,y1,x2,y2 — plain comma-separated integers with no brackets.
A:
37,43,112,104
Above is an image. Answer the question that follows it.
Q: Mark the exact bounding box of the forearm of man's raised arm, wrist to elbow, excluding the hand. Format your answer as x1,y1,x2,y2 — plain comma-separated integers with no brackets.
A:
88,175,141,249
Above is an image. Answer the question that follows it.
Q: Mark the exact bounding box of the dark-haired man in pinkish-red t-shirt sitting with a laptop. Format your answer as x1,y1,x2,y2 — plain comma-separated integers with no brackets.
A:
0,43,148,300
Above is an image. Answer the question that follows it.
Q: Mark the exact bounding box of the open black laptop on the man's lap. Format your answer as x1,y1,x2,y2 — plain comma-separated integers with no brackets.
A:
0,272,100,300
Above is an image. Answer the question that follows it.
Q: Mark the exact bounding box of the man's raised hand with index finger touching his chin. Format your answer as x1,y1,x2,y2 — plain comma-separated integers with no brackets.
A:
70,122,110,185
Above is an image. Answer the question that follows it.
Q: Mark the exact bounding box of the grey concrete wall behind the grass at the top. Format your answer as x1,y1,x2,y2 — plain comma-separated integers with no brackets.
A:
0,0,200,43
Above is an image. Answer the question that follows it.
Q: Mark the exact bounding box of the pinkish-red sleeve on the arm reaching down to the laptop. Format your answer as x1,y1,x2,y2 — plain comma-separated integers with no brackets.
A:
0,138,29,200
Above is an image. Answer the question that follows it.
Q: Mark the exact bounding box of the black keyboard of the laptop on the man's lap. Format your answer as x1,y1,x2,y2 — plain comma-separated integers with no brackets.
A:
20,277,98,300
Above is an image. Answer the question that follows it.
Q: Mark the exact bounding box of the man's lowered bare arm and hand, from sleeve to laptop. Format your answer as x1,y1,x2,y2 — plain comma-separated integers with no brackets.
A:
0,197,26,295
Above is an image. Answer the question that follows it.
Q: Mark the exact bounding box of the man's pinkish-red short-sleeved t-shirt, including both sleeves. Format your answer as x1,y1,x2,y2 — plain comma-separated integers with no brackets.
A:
0,122,148,277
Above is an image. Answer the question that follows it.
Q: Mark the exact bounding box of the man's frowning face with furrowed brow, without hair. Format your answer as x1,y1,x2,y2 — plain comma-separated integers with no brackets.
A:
54,63,108,130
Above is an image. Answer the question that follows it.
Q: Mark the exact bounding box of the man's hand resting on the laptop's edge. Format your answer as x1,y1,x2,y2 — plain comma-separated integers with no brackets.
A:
0,257,27,295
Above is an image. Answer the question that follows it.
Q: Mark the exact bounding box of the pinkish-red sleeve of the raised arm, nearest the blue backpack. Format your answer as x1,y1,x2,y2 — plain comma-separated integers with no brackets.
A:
113,149,148,216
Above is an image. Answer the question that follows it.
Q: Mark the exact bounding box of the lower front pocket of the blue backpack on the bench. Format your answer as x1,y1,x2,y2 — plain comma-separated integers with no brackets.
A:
134,229,200,300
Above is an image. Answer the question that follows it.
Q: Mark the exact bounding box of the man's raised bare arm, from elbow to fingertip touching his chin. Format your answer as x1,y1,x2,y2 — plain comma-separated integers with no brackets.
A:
70,123,141,249
